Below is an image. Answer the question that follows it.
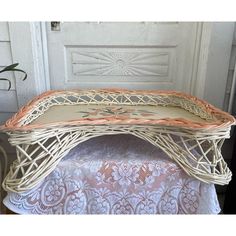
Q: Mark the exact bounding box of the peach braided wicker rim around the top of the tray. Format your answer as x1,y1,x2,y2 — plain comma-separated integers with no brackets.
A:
0,89,236,131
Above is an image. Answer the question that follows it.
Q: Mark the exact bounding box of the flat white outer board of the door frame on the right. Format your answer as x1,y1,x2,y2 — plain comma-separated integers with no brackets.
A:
203,22,234,109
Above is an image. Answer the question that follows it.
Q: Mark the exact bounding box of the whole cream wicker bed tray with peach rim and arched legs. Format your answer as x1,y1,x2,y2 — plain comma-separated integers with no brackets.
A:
1,89,235,192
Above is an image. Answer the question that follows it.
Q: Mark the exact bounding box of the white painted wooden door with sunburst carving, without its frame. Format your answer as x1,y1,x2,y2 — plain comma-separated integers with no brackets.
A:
47,22,201,92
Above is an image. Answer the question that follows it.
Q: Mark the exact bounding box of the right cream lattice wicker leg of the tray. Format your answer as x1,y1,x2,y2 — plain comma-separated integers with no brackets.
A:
131,132,232,185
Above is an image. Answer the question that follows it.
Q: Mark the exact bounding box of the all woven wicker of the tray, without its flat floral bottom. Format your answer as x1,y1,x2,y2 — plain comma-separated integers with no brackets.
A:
0,90,234,192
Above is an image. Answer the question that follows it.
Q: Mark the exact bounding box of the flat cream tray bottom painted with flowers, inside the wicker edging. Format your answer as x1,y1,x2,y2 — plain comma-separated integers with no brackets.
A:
31,104,207,124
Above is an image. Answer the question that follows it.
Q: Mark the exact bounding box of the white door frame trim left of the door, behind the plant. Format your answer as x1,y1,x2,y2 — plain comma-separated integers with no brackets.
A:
9,22,50,107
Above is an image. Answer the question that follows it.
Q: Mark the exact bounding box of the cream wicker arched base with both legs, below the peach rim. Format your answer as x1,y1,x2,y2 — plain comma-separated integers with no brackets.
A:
3,125,231,192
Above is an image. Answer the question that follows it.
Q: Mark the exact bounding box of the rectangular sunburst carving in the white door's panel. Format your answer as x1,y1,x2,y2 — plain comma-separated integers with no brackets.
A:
71,51,170,76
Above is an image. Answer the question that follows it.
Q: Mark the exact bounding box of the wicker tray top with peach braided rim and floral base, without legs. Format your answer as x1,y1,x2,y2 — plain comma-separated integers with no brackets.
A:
0,89,235,131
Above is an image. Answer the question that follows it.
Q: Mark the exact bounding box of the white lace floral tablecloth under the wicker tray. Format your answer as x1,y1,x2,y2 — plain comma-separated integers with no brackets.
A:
4,135,220,214
